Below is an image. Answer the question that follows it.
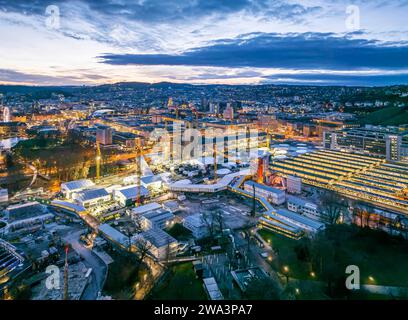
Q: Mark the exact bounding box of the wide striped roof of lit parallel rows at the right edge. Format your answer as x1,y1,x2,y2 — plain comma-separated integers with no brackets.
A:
272,150,408,214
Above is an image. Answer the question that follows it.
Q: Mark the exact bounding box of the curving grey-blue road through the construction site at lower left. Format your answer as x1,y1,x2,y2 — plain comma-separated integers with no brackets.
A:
64,230,108,300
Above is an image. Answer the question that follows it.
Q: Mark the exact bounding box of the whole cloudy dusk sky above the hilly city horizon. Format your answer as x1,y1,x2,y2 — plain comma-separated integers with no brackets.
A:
0,0,408,86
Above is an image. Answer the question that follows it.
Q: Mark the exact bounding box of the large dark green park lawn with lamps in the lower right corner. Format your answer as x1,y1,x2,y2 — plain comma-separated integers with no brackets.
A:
259,225,408,287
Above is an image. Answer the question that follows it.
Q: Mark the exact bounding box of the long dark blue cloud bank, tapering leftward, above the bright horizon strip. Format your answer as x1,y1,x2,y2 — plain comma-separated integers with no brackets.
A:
100,33,408,70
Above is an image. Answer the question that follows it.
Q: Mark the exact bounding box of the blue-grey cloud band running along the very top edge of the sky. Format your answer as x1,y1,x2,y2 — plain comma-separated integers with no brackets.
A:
0,0,319,24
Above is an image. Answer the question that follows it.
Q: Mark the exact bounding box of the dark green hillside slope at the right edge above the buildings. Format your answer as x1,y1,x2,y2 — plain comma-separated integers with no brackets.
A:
360,107,408,126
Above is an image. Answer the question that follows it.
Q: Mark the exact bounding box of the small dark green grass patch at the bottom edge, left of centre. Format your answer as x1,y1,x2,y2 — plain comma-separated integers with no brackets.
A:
150,262,207,300
